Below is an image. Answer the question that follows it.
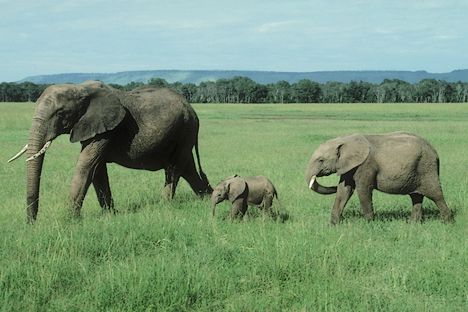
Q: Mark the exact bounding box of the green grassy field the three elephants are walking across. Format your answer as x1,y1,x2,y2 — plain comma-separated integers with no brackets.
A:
0,103,468,312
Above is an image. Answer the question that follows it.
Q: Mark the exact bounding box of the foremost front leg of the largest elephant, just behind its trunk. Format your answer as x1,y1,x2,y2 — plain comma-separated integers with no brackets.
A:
70,139,108,217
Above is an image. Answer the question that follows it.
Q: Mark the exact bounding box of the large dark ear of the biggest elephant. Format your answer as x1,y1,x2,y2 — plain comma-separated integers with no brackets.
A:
70,90,126,143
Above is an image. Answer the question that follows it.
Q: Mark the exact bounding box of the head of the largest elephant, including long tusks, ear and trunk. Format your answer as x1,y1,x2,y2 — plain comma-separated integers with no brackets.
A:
10,81,126,222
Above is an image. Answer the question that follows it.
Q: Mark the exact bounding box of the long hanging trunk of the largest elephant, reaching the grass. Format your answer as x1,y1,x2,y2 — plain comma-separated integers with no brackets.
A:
26,115,46,223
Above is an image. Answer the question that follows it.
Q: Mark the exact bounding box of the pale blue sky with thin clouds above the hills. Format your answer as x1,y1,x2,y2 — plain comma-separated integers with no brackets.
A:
0,0,468,81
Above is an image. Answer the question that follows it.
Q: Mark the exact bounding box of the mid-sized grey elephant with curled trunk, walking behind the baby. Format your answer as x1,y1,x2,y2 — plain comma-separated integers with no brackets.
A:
306,132,452,224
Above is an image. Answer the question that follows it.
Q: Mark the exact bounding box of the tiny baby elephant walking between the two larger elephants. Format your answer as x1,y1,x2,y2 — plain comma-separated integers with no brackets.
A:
211,175,278,219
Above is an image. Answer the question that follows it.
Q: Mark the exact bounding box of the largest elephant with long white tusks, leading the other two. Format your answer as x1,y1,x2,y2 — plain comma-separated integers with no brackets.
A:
10,81,213,222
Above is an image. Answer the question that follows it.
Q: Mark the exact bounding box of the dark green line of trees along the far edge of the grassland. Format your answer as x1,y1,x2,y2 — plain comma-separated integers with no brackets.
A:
0,77,468,103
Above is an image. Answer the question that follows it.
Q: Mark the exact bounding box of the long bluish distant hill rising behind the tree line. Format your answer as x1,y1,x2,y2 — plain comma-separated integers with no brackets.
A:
20,69,468,85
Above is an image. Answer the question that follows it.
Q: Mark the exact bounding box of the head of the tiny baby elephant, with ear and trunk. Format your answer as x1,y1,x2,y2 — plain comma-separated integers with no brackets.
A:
211,175,247,216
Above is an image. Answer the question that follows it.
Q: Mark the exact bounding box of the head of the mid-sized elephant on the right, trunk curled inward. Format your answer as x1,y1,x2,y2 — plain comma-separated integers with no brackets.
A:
306,134,370,194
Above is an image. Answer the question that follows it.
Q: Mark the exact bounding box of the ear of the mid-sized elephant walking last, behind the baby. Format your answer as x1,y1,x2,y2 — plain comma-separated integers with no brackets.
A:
336,135,370,175
